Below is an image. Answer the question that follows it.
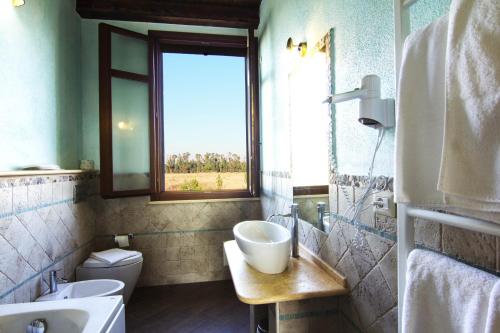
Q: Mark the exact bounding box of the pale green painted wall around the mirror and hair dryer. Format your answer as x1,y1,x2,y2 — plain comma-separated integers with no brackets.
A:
259,0,449,176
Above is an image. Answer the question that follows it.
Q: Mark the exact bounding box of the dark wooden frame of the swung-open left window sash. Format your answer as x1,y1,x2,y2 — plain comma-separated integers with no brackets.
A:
99,23,152,198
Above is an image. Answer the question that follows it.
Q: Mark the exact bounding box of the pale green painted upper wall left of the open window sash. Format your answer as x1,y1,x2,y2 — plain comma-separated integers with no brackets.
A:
0,0,81,170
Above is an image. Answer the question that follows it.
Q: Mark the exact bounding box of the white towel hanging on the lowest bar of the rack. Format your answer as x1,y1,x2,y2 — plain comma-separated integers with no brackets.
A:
402,250,500,333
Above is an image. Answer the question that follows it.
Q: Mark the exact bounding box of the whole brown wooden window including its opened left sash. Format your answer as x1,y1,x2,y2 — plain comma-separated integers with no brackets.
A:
99,24,260,200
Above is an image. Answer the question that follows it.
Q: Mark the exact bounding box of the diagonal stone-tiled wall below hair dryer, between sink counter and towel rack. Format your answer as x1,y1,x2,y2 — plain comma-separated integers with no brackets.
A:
303,182,397,332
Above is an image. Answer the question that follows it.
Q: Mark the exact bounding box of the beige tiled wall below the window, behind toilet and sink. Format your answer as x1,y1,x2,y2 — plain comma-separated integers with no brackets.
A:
93,197,262,286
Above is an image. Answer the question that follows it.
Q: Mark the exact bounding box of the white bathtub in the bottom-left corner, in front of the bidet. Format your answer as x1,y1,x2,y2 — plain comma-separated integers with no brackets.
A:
0,296,125,333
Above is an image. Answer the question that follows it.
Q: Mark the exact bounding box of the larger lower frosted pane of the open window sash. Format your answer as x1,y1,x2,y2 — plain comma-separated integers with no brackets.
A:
111,78,149,191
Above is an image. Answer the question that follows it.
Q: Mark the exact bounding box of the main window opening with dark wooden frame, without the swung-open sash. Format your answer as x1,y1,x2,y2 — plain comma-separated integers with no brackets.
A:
149,31,259,200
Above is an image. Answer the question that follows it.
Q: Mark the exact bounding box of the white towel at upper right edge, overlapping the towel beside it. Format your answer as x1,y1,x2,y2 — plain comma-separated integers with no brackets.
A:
438,0,500,212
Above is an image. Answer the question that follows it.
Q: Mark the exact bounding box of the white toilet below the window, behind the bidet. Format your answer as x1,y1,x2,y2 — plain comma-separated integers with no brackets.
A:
76,252,142,303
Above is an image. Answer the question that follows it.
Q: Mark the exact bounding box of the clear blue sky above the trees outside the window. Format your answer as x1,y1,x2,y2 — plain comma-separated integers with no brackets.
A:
163,53,246,157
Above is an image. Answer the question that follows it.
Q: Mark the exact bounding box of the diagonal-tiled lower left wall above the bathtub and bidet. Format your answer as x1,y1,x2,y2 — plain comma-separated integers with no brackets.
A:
0,174,95,303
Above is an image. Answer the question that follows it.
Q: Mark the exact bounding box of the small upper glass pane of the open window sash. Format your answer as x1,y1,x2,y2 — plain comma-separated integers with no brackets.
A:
111,33,148,75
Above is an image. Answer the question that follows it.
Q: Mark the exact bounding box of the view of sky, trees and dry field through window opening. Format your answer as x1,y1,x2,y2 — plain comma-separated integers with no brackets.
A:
163,53,248,192
